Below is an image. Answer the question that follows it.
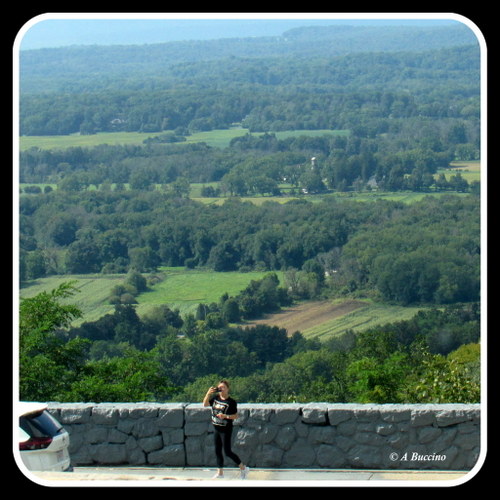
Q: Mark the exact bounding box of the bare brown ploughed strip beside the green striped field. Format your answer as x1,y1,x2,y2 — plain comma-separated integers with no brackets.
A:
247,300,366,335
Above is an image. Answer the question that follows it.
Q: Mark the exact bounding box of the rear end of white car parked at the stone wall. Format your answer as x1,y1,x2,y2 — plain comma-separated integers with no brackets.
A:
17,402,70,471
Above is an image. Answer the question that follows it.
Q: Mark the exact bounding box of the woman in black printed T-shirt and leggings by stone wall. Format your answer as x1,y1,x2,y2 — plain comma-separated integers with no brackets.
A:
203,380,250,479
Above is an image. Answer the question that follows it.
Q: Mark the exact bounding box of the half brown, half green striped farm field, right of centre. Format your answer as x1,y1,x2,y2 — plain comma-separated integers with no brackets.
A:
244,299,422,340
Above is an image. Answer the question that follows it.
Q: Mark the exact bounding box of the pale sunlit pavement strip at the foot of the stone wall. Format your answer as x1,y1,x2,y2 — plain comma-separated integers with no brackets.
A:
28,467,472,486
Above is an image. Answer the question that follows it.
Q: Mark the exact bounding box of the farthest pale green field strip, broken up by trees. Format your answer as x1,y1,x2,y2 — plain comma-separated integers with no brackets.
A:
19,127,349,151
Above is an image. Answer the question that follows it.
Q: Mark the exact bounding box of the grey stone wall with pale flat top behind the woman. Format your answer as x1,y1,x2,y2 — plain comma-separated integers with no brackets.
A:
49,403,480,470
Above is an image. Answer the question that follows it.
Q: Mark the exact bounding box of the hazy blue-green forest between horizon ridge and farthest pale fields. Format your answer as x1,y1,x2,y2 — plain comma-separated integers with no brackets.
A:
20,46,479,135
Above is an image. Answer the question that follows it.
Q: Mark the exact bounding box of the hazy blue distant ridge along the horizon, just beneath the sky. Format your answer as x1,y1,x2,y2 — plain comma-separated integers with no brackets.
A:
20,24,477,93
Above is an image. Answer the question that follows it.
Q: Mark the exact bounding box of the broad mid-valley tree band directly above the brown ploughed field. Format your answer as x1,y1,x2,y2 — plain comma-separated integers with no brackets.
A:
20,191,480,305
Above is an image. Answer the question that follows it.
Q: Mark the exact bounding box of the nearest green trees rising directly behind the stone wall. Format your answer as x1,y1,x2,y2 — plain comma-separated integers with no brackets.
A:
19,282,480,403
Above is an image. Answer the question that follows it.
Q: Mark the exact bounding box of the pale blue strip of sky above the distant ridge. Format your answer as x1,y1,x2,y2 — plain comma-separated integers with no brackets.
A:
16,13,460,50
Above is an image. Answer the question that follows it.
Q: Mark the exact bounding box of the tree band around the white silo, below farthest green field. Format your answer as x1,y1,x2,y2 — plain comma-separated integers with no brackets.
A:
20,120,479,197
